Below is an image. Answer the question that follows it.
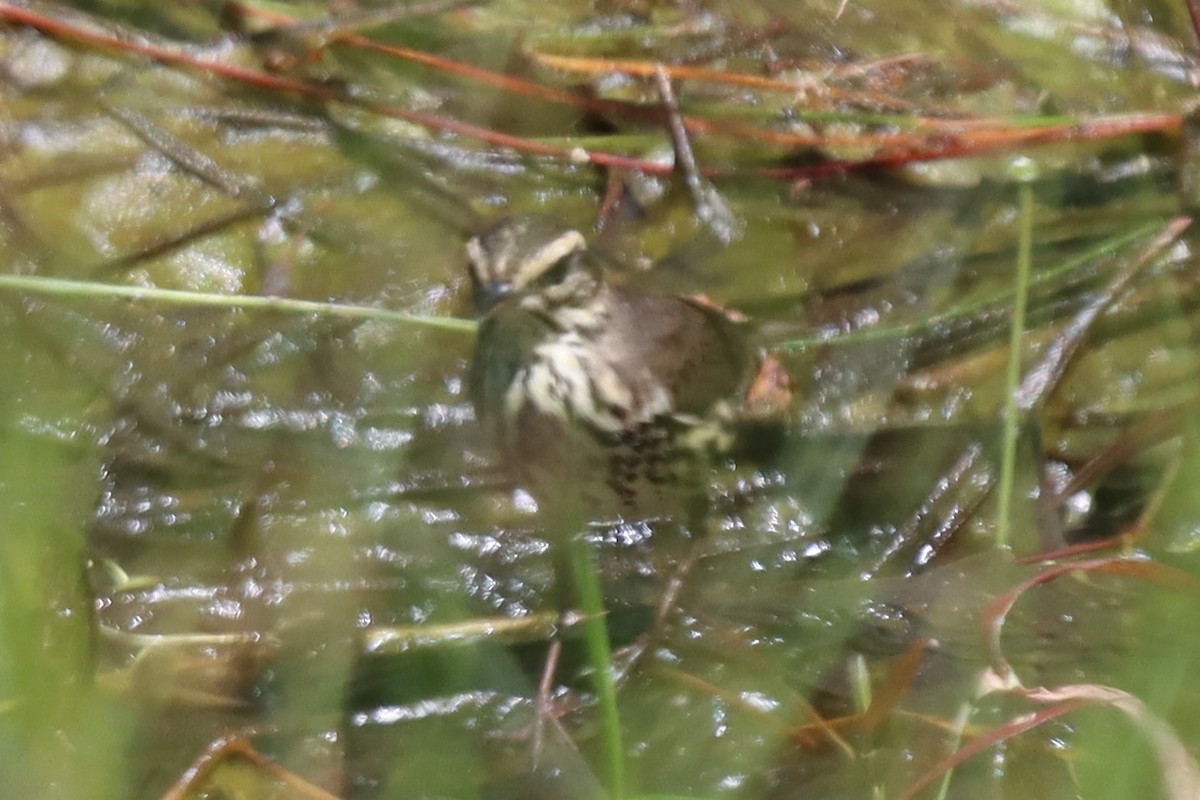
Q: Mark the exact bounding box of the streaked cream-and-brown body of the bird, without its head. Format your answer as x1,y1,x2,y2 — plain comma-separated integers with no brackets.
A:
472,280,750,513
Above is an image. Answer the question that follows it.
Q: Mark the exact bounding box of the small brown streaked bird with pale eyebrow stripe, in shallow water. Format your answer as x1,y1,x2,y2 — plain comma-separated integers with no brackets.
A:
466,215,787,518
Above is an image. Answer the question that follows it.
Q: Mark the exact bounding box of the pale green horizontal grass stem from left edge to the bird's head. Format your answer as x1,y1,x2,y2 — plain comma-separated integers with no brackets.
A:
0,275,478,333
